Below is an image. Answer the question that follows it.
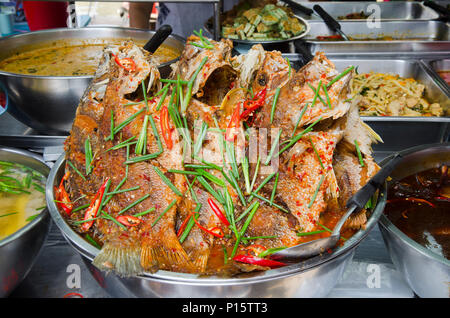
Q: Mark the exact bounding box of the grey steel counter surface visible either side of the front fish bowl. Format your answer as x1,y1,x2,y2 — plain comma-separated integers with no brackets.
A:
6,200,414,298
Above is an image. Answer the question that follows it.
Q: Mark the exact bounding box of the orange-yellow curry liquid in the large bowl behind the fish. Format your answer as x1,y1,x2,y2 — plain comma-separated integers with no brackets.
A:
0,40,180,76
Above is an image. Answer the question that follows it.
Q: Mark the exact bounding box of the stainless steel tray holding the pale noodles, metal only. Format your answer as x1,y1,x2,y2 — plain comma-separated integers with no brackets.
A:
283,54,450,153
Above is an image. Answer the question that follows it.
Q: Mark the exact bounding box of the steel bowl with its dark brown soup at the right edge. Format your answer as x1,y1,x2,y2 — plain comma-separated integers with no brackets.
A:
379,143,450,298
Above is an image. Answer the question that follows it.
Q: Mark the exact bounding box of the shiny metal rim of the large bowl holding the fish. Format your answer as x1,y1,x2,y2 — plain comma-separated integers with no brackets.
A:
45,153,386,285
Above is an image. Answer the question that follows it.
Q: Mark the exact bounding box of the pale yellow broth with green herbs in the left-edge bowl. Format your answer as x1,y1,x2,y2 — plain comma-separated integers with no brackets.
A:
0,162,46,240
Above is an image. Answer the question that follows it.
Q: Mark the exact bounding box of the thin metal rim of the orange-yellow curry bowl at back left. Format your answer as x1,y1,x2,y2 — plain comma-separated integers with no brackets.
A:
0,26,186,80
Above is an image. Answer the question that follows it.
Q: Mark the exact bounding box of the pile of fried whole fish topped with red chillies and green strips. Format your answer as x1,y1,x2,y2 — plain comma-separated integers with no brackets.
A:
61,34,380,276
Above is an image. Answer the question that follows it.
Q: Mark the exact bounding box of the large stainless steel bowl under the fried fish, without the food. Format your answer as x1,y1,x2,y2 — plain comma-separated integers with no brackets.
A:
46,155,386,298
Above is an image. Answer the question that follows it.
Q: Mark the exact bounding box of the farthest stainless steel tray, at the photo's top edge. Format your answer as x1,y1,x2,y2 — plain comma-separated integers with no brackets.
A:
292,0,439,21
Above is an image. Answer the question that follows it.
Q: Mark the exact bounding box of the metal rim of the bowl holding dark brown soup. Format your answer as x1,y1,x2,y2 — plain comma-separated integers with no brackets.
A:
379,142,450,266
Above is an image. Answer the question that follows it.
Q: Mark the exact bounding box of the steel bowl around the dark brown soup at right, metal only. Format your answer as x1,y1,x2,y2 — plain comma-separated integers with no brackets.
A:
379,143,450,297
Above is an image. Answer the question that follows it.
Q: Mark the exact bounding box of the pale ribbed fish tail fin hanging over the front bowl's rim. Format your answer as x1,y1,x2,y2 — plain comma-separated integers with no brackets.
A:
92,242,144,277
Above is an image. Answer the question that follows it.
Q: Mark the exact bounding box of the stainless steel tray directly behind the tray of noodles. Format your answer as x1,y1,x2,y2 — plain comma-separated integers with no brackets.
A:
303,21,450,55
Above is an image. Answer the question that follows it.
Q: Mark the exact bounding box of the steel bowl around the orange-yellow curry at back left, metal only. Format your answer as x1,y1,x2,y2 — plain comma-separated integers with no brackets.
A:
0,27,184,134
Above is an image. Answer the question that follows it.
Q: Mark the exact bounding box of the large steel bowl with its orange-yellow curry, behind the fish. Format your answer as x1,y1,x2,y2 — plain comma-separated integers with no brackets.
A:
0,27,184,134
